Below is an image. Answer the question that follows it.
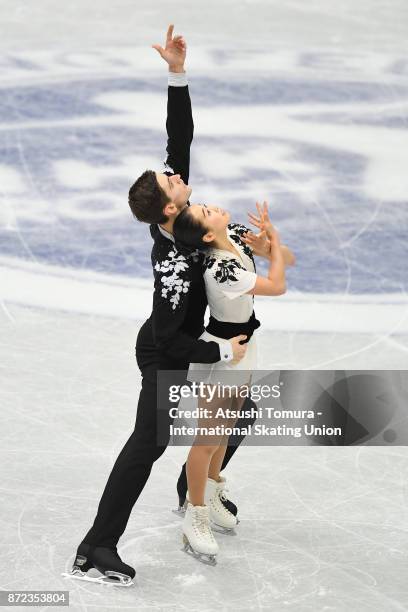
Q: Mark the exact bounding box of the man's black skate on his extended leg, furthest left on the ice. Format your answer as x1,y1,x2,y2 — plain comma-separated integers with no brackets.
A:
62,542,136,586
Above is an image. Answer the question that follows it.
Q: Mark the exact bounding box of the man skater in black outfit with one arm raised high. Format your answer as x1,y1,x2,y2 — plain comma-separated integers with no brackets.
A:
64,25,262,586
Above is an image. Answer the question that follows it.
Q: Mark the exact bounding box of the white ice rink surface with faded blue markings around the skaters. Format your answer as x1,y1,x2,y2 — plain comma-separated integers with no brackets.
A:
0,0,408,612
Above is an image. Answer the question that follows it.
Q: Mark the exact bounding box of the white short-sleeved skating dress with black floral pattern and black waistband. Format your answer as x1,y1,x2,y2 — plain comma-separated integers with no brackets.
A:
187,223,259,383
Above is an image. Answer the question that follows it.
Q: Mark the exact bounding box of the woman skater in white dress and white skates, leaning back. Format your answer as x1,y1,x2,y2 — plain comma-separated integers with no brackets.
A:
173,202,295,564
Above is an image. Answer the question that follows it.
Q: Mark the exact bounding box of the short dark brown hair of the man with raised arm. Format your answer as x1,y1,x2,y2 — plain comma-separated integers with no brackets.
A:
129,170,171,223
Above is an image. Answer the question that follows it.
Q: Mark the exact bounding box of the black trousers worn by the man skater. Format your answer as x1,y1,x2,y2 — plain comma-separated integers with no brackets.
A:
83,364,256,547
